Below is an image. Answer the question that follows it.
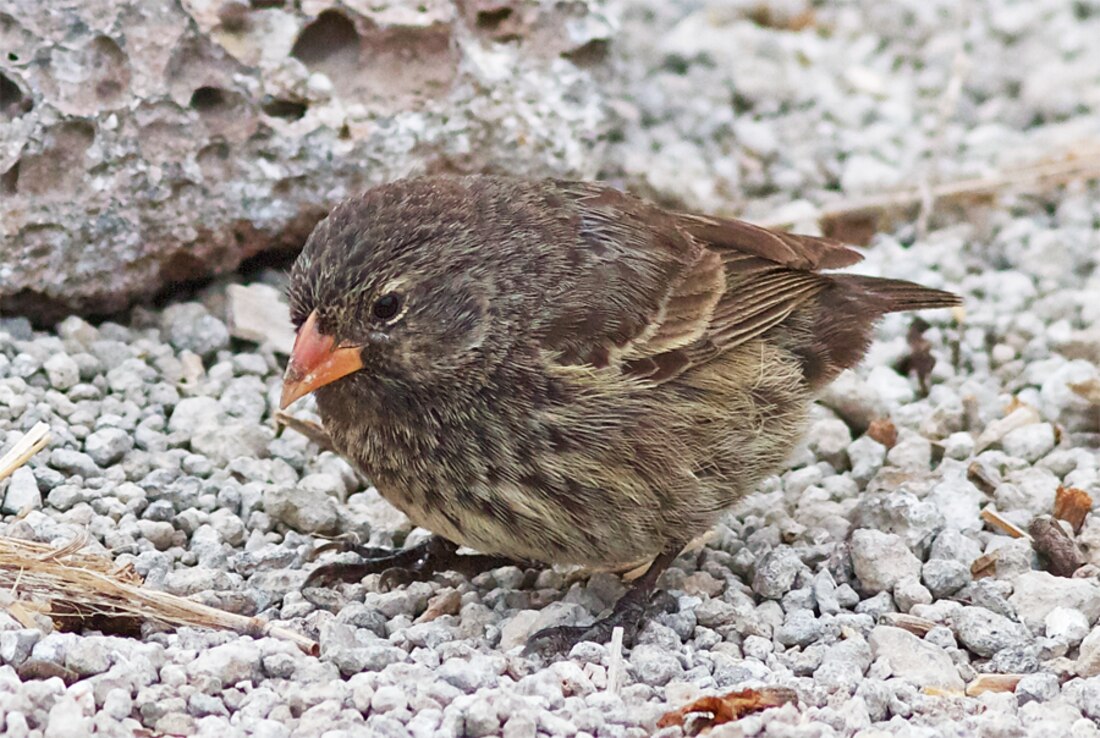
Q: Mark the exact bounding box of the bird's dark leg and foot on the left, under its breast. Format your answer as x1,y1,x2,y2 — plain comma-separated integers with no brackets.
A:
301,536,518,590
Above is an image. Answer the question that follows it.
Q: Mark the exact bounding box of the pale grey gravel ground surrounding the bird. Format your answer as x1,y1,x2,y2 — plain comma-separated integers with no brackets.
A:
0,0,1100,738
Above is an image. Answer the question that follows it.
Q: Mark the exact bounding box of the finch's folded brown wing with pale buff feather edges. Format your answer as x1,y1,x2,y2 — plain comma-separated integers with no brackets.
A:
541,183,861,383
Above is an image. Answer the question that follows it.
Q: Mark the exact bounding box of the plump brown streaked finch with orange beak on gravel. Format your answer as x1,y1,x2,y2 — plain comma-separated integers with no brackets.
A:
279,175,960,651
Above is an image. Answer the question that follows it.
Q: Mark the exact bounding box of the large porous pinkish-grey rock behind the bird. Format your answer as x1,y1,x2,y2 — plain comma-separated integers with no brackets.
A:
0,0,612,321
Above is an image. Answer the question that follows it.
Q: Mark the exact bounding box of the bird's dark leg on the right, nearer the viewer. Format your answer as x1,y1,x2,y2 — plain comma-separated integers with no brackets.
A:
524,547,682,654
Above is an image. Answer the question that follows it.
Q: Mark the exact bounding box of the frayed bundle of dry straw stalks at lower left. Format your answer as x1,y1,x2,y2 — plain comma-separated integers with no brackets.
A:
0,538,319,654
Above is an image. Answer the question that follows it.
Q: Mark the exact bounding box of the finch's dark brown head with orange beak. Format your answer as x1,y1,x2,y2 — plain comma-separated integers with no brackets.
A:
281,179,519,408
